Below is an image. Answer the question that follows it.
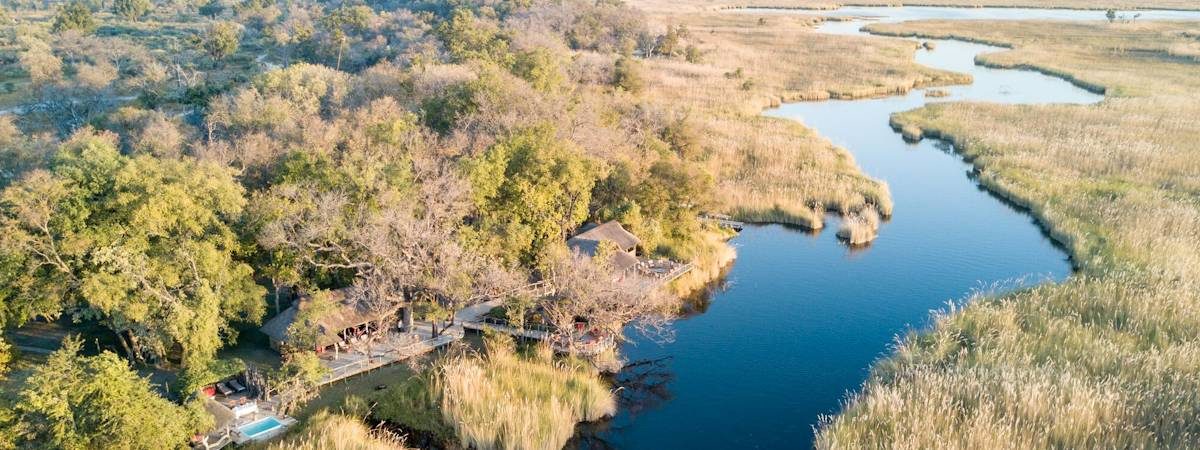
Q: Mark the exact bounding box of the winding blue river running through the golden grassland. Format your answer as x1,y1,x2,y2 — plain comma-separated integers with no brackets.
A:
578,7,1200,449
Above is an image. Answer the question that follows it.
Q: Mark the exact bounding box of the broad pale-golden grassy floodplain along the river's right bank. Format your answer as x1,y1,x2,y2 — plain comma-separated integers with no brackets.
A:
817,16,1200,448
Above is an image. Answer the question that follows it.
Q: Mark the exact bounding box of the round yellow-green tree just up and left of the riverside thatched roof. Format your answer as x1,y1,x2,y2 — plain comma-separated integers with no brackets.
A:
467,126,595,265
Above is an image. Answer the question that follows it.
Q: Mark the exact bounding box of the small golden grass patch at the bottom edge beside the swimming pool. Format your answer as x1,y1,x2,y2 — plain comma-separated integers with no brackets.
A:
266,412,404,450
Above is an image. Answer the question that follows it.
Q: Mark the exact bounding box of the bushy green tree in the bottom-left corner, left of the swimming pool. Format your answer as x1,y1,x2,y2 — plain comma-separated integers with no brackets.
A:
14,338,211,450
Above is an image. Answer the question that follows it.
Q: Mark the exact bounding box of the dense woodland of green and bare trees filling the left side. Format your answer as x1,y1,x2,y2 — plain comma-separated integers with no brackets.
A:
0,0,724,449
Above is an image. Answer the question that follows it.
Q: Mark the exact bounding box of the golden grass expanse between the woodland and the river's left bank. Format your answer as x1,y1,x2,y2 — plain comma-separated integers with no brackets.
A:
636,8,970,229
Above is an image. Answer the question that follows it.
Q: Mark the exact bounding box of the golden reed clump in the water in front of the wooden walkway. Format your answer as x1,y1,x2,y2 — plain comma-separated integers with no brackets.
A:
377,336,617,450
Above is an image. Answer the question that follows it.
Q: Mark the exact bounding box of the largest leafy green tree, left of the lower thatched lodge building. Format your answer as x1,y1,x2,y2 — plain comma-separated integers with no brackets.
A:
0,132,265,367
